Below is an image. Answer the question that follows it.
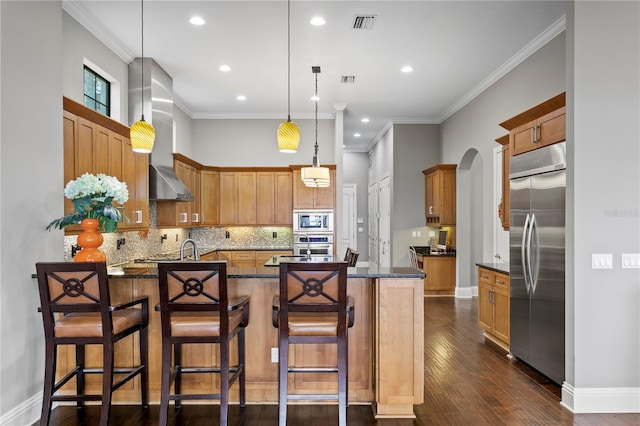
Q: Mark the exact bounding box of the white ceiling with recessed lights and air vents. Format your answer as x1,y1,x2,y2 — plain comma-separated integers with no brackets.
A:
63,0,565,151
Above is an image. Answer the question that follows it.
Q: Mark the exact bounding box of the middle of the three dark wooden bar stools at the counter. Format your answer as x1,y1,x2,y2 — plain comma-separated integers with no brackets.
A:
158,262,249,425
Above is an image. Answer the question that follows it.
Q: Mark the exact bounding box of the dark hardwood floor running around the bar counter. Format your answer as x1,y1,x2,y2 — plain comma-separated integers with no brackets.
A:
42,297,640,426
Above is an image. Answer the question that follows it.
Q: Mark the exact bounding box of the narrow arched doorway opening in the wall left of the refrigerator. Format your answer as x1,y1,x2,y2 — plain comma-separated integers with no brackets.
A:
456,148,485,297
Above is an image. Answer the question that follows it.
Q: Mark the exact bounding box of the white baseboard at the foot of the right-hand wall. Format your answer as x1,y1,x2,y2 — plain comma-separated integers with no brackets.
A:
561,382,640,413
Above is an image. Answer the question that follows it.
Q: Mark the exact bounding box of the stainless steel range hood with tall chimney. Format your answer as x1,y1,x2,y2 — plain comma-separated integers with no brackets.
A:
129,58,194,201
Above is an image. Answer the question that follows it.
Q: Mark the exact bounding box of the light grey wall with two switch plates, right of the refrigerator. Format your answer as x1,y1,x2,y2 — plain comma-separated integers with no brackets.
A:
563,2,640,412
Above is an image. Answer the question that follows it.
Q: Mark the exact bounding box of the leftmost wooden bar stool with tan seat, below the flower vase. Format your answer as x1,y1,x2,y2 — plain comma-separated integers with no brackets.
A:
36,262,149,426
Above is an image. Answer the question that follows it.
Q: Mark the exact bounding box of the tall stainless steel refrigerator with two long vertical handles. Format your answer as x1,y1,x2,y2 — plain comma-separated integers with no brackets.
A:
509,142,566,384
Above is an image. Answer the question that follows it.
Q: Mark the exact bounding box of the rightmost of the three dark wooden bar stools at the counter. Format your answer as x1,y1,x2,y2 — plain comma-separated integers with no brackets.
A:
272,262,354,426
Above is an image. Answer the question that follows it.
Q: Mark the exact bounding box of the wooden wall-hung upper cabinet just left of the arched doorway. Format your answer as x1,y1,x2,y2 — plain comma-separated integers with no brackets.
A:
422,164,456,227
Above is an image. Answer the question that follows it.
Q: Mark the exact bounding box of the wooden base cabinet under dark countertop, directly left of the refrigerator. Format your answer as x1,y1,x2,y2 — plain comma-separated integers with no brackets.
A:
478,267,510,350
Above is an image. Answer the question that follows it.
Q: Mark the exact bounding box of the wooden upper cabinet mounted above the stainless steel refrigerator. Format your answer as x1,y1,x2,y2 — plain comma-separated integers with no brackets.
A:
500,92,566,155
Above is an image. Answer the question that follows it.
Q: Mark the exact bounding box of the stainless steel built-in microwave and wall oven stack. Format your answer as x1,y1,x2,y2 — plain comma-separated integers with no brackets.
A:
293,210,334,257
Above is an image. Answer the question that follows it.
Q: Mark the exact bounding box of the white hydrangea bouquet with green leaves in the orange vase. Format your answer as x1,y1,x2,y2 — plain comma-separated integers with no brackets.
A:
47,173,129,232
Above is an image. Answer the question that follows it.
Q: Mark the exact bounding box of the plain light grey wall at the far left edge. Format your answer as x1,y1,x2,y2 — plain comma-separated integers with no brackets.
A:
0,1,64,425
